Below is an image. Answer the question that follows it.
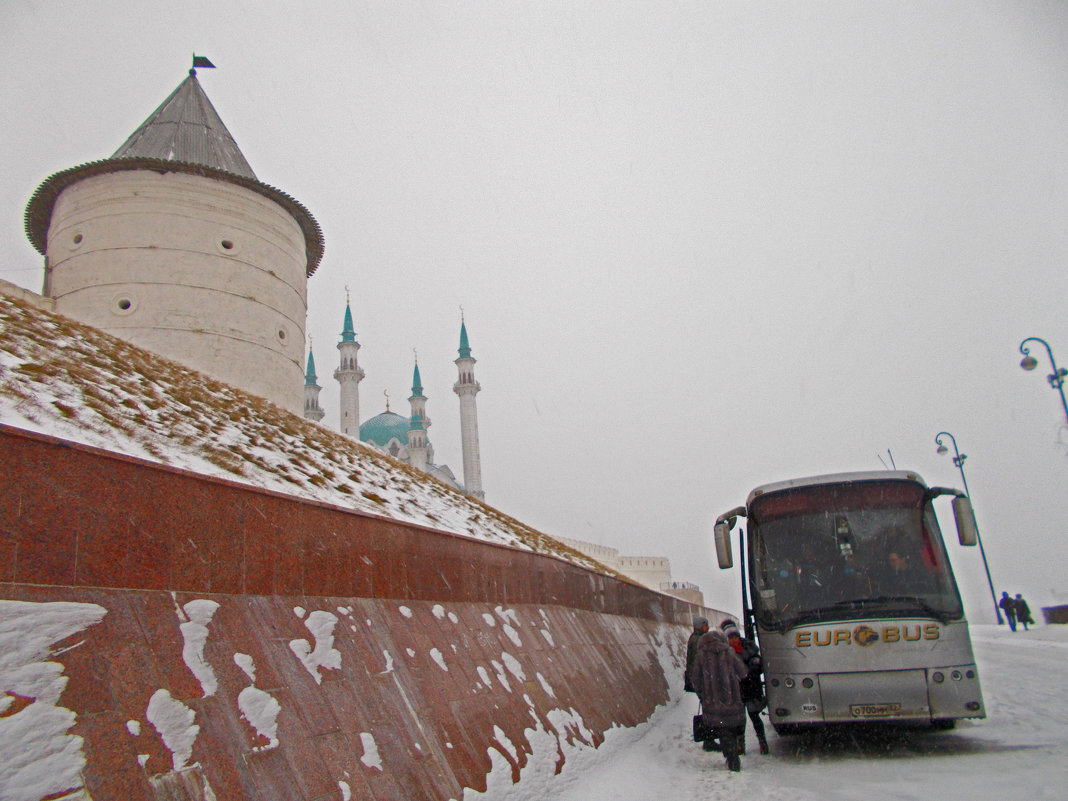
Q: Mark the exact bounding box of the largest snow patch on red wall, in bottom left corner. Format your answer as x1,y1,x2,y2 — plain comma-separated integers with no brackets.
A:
0,600,108,801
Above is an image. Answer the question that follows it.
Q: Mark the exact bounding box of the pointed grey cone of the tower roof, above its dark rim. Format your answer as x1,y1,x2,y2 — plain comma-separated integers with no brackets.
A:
111,69,256,180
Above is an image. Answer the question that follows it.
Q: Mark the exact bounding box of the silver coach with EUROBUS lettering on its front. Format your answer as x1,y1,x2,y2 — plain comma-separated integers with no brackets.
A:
714,470,986,734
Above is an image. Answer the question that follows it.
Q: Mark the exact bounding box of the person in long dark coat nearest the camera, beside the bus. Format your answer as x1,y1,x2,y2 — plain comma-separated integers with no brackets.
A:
690,629,749,771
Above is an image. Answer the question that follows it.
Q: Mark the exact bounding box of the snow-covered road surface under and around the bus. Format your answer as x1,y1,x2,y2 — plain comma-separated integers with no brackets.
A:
476,626,1068,801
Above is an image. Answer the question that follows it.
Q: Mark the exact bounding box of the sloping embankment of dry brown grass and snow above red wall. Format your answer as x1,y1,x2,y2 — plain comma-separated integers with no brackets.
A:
0,293,611,572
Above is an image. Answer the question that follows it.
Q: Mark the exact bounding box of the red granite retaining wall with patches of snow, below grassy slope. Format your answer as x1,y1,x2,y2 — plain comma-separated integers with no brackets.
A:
0,425,716,801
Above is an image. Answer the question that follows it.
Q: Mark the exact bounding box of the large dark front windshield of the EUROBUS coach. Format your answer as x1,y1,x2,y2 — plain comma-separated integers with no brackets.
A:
749,481,963,630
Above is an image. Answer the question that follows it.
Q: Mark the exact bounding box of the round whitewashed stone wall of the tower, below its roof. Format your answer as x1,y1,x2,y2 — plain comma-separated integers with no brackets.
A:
44,170,308,414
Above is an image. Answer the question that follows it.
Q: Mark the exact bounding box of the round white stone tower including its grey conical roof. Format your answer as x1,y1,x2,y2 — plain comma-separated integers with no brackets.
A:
26,64,323,414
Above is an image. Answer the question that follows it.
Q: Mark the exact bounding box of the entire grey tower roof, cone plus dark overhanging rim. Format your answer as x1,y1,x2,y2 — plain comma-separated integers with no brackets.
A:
26,69,324,276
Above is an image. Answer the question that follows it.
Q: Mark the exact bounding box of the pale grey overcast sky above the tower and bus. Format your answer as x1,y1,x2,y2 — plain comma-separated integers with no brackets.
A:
6,0,1068,619
